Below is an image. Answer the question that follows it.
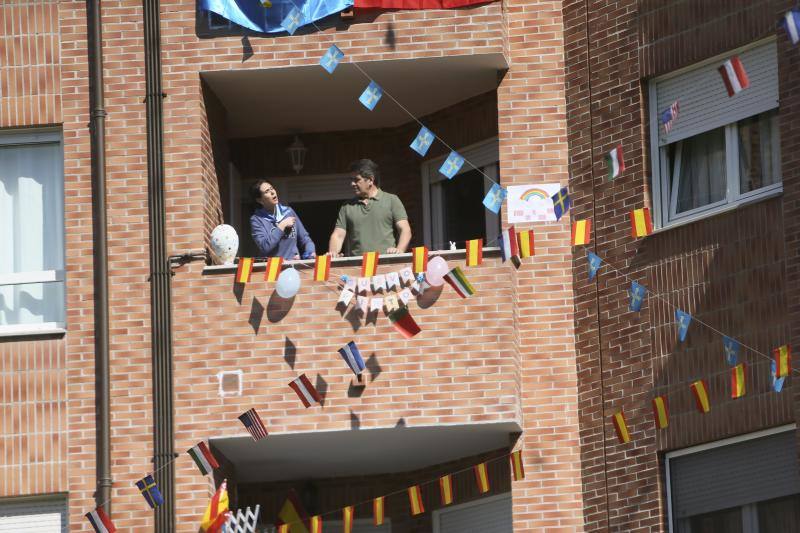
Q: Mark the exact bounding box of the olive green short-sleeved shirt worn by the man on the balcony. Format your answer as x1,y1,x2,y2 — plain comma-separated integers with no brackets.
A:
336,190,408,255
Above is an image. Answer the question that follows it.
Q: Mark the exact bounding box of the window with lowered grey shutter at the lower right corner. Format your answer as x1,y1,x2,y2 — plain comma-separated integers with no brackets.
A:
665,425,800,533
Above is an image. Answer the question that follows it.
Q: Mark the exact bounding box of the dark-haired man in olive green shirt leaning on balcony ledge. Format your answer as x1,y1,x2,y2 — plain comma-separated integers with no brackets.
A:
328,159,411,257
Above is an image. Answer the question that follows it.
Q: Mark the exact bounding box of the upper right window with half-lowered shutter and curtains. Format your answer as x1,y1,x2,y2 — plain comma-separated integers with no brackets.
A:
650,40,782,227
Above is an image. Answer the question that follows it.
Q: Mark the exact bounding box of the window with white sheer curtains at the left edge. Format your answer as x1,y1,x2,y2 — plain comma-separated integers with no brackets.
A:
0,132,64,335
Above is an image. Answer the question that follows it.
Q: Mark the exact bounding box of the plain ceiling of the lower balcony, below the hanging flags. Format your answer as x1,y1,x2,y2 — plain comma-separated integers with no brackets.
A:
211,422,520,483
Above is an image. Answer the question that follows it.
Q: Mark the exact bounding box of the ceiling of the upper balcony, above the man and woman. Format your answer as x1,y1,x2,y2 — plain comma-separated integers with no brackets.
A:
201,54,508,138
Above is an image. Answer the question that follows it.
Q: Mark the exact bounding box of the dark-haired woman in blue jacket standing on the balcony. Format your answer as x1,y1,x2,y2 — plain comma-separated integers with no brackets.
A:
250,180,317,259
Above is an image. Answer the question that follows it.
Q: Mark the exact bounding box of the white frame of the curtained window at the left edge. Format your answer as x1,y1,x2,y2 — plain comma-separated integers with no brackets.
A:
0,130,67,337
